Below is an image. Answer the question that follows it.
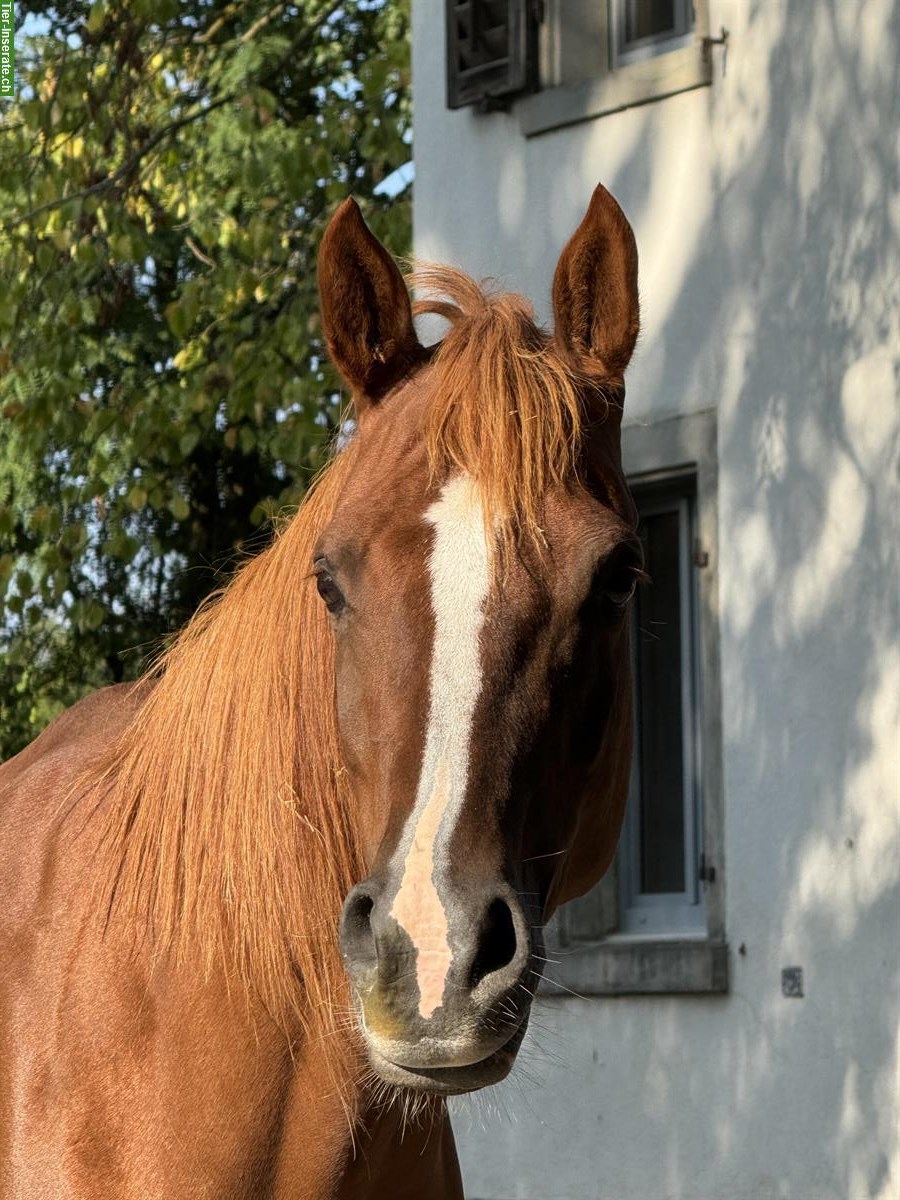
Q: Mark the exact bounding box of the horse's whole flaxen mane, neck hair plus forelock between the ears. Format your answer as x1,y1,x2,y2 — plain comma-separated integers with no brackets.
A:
91,268,595,1099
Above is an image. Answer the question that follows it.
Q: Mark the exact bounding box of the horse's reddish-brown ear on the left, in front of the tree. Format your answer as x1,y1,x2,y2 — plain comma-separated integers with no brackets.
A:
318,197,422,412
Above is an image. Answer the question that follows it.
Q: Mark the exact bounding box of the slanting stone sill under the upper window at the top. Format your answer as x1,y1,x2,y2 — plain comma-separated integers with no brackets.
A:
516,41,713,137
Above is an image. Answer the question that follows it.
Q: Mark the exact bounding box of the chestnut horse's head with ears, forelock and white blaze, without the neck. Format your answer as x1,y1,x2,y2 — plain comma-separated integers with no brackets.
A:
310,187,642,1093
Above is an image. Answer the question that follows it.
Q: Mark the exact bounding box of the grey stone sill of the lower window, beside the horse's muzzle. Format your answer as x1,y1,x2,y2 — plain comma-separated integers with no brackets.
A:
540,936,728,996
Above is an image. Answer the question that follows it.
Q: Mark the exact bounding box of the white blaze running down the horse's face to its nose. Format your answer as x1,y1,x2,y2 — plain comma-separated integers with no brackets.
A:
391,475,491,1020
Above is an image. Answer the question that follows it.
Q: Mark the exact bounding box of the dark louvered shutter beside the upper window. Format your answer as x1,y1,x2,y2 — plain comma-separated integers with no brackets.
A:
446,0,538,110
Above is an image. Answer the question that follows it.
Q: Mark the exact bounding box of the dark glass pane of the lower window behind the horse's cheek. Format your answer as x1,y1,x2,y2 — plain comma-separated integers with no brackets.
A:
636,511,685,893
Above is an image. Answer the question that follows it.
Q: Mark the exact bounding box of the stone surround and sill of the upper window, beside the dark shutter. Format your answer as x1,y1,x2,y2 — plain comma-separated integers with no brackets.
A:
516,0,713,137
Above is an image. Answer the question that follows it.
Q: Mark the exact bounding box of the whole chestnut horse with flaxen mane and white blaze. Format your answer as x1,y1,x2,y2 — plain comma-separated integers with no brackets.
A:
0,187,641,1200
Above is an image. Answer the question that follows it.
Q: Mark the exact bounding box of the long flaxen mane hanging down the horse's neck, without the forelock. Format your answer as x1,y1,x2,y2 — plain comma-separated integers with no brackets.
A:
88,446,360,1099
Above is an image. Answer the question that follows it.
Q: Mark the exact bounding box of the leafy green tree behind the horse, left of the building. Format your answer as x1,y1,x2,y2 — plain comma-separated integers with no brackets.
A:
0,0,409,758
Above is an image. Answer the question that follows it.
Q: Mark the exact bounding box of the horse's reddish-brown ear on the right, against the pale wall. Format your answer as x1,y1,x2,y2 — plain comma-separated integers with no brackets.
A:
553,184,641,380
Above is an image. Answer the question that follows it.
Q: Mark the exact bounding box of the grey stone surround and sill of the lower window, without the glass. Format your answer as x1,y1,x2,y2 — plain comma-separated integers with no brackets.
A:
542,410,728,996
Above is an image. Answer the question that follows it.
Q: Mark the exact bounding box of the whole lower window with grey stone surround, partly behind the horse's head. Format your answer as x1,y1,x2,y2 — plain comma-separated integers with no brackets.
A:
547,413,727,994
